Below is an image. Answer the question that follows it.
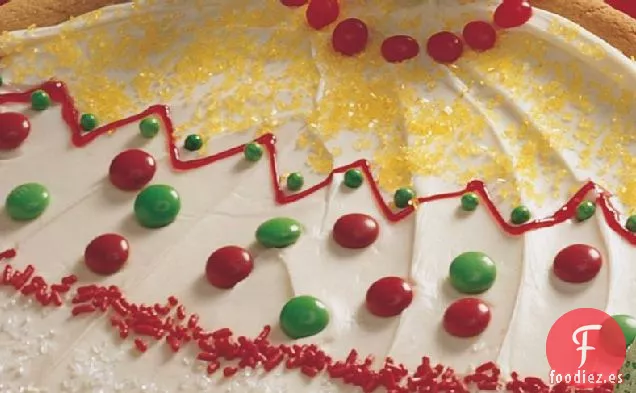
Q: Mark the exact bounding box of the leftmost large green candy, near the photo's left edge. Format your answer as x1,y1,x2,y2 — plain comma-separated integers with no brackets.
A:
5,183,50,221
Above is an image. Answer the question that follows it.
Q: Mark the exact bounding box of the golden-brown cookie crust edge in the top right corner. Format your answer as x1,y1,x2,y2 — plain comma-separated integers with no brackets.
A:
530,0,636,57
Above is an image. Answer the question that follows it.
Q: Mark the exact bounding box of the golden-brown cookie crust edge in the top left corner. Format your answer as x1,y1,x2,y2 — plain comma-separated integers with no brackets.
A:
0,0,126,33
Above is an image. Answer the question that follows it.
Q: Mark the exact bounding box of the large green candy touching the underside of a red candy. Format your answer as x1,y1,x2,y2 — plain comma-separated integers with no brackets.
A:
135,184,181,228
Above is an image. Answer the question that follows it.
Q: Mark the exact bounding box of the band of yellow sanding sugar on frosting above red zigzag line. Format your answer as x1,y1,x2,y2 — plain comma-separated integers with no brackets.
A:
0,0,636,206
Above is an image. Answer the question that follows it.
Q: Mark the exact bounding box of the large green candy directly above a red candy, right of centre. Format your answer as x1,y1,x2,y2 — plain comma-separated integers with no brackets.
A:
449,251,497,294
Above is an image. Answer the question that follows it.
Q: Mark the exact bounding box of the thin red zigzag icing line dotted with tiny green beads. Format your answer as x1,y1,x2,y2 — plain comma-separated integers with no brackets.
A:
0,81,636,245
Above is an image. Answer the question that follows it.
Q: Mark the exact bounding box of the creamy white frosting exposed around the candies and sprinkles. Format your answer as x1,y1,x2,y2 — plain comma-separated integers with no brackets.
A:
0,1,636,392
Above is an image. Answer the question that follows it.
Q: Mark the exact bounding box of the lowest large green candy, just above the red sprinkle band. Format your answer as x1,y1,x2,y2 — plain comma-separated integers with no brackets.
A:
279,296,329,339
